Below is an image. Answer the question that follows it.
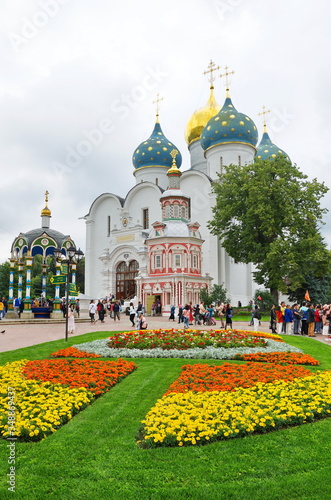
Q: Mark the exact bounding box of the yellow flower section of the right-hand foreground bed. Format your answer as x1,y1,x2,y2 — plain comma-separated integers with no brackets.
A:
138,365,331,447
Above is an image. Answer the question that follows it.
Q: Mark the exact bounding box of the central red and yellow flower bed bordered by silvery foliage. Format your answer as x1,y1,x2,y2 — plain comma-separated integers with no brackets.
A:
108,330,282,350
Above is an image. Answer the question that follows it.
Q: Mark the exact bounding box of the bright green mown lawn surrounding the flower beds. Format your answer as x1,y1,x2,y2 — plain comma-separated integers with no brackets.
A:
0,332,331,500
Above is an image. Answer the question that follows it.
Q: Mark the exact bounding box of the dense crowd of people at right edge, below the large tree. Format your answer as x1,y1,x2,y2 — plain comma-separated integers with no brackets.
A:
270,302,331,337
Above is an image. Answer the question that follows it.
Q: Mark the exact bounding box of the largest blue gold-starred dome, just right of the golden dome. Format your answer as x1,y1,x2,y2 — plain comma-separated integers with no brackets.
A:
201,91,258,151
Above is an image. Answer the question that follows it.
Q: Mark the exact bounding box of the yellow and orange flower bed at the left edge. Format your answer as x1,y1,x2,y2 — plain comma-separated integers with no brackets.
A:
0,359,136,441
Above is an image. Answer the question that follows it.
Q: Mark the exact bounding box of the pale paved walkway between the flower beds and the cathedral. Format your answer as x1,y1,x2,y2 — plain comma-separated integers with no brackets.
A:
0,315,331,352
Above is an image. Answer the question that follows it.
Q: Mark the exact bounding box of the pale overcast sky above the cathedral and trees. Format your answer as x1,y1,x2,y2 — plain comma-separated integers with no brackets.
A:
0,0,331,262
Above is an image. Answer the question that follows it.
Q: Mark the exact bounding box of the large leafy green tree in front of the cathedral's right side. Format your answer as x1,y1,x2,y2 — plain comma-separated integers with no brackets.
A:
208,155,329,303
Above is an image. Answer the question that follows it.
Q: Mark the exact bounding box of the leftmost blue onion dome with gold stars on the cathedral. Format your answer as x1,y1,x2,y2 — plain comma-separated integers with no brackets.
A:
132,120,182,169
